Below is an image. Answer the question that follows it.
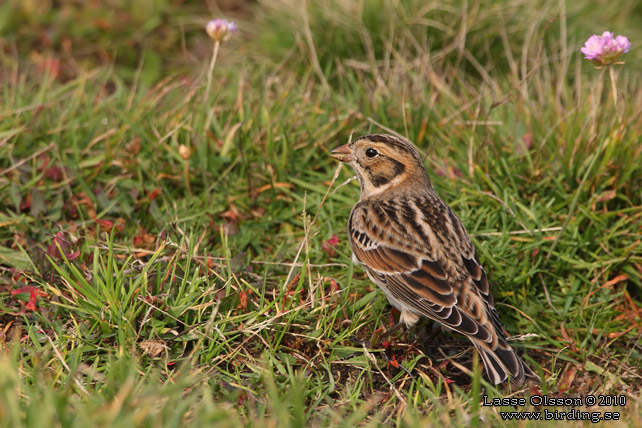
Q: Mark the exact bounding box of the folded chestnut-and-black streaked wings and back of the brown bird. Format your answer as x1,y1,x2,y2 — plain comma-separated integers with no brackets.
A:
348,196,505,348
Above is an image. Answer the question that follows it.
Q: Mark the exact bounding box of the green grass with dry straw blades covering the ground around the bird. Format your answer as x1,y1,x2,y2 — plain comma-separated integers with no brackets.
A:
0,0,642,427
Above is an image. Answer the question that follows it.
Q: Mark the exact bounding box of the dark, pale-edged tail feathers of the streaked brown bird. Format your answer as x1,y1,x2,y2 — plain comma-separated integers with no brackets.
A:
475,343,540,386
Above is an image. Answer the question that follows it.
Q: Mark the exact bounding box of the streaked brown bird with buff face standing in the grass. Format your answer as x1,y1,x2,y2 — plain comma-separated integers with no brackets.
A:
330,134,539,386
